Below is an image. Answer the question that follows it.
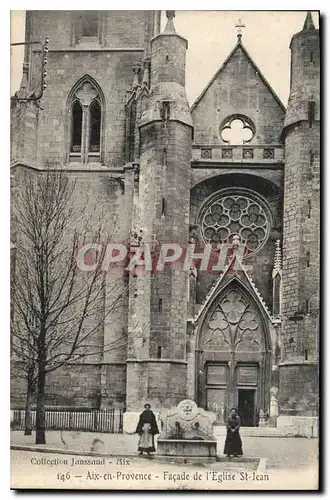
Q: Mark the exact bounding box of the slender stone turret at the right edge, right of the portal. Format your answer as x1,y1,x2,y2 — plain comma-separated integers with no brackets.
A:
279,13,320,415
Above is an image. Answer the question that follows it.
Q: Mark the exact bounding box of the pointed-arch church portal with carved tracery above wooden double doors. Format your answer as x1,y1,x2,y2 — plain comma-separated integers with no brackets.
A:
196,277,271,426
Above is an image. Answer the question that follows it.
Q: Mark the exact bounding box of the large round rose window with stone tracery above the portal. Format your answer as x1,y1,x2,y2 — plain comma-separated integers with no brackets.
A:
202,194,270,253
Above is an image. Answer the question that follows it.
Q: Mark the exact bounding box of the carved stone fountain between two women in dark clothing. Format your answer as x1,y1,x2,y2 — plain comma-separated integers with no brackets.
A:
157,399,217,461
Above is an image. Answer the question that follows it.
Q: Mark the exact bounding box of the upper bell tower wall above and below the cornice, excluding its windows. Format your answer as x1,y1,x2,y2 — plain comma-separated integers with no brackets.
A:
24,11,159,166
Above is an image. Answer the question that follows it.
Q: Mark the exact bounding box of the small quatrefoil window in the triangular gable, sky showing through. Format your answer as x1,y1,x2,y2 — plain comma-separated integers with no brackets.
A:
220,115,255,145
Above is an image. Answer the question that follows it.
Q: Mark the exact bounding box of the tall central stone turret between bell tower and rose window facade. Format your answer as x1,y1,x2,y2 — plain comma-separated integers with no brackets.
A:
127,11,192,411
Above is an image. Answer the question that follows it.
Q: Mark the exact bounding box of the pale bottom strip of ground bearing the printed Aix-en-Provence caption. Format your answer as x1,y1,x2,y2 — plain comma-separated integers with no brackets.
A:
11,450,317,490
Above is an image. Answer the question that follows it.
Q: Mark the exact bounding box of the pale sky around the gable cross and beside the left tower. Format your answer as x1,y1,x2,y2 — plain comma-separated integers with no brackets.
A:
11,10,318,105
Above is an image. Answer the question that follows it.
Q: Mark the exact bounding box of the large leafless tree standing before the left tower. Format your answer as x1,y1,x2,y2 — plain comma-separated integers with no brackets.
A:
11,170,137,444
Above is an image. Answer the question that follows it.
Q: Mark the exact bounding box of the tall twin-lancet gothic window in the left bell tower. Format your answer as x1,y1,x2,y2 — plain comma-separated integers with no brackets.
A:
68,76,104,163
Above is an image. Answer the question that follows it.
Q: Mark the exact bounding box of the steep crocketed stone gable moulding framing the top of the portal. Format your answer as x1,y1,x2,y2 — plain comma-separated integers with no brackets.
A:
193,253,274,323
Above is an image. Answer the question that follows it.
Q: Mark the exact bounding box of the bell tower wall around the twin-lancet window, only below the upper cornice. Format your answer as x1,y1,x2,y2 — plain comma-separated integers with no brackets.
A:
30,50,141,168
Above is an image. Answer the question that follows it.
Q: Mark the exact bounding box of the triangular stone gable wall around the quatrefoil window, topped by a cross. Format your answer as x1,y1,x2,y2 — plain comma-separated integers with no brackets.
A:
192,42,284,145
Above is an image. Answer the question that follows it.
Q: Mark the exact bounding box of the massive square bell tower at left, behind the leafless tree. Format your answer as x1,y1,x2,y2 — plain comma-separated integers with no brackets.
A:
12,10,160,407
